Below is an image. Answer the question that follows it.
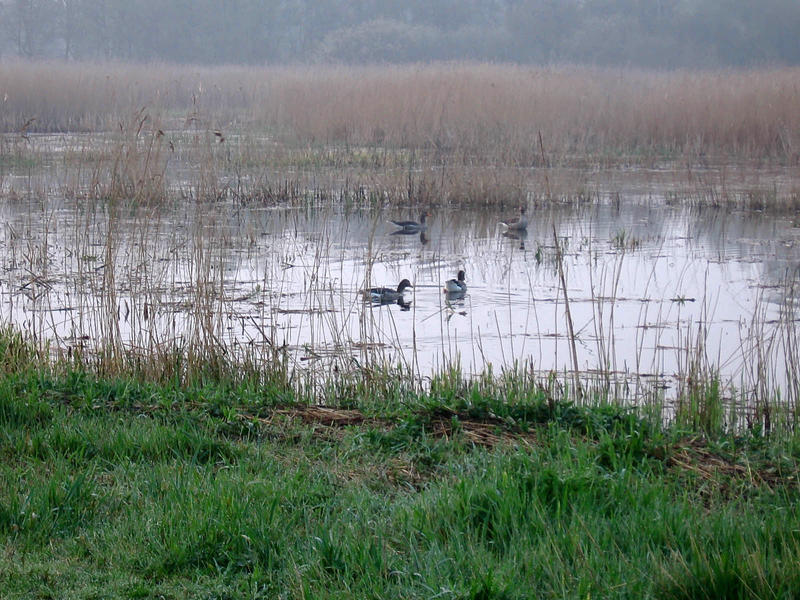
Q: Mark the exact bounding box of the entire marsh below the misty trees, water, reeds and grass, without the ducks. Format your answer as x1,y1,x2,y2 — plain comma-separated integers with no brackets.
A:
0,62,800,599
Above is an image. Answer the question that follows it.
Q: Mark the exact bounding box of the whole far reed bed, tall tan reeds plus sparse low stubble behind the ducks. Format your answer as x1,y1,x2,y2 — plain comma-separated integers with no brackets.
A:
0,62,800,211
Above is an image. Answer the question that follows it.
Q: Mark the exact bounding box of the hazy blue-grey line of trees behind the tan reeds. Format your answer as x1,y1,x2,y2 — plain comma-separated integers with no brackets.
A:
0,0,800,68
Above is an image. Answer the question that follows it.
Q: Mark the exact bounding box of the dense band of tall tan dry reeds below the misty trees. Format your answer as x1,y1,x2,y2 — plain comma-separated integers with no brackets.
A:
0,61,800,165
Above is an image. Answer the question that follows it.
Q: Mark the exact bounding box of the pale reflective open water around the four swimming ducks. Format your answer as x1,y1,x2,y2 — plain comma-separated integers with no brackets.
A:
0,190,800,395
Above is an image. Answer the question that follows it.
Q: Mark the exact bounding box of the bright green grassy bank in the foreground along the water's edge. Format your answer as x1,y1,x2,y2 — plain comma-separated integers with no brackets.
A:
0,335,800,598
